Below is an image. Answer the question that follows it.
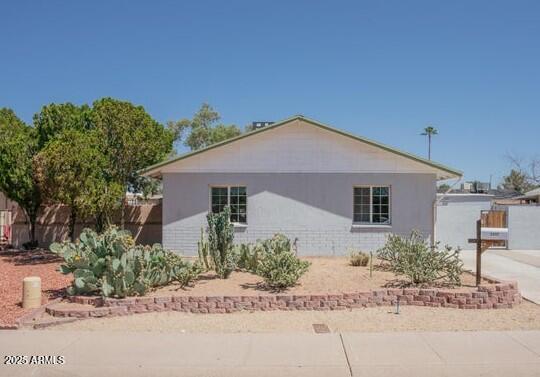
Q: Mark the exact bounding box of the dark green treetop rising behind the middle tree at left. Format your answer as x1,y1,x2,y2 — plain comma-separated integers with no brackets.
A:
33,102,92,150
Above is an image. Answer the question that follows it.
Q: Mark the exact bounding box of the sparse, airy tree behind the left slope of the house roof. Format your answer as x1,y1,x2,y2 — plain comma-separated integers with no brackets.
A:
174,103,242,150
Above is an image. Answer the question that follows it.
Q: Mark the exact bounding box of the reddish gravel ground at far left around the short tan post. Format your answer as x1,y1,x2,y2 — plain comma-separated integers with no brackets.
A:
0,250,71,325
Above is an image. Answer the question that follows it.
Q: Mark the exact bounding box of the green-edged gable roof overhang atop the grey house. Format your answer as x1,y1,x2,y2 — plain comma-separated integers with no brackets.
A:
139,115,463,179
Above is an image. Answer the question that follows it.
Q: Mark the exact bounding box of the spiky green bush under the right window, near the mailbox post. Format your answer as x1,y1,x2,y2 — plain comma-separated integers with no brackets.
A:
377,230,463,285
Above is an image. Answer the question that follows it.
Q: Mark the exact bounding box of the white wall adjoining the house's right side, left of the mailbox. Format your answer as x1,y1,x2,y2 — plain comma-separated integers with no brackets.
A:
435,196,491,250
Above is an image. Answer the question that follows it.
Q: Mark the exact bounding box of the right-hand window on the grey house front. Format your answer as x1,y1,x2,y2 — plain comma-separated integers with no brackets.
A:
353,186,390,224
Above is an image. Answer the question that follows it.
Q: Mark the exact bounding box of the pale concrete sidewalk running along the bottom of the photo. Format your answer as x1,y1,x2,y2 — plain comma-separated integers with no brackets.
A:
0,331,540,377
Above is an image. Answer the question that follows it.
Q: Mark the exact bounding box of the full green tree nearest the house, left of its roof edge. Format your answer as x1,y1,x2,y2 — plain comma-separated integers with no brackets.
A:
91,98,175,225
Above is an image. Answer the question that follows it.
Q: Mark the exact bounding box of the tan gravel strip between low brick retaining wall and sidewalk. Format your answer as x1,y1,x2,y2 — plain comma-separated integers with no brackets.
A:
50,302,540,333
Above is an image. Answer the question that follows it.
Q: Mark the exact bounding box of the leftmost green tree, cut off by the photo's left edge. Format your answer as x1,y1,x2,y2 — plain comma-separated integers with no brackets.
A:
0,108,41,245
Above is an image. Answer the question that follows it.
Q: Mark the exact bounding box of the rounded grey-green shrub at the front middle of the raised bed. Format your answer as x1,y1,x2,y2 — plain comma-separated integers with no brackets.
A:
256,234,310,290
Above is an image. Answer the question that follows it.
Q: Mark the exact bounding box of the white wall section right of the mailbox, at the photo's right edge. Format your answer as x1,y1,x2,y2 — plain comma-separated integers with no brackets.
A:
507,206,540,250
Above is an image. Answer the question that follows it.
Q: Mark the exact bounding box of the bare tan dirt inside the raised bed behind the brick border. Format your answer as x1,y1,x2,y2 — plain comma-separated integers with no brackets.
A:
149,257,486,296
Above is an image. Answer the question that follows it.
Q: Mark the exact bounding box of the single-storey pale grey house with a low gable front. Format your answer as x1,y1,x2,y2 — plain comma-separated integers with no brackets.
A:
142,115,462,255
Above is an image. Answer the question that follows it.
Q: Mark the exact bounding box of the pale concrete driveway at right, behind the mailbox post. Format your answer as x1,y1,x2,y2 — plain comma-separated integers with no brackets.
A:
461,249,540,304
